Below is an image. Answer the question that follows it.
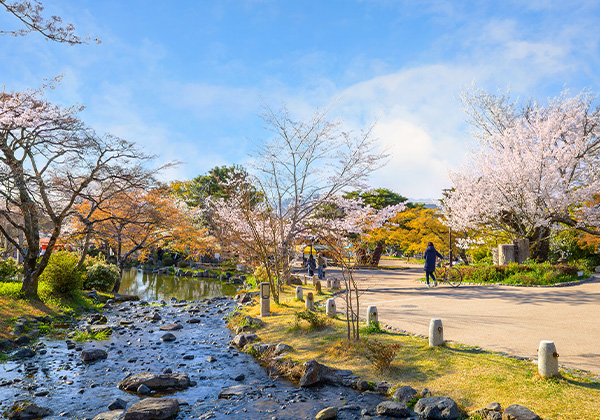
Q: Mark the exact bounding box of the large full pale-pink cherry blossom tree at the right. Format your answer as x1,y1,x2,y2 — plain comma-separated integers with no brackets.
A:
444,88,600,260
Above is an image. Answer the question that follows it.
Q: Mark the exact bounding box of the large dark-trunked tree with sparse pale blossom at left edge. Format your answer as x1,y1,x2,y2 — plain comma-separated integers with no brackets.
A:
0,91,150,298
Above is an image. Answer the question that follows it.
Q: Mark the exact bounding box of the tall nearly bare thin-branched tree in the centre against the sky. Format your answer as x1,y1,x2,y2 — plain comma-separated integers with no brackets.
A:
252,105,387,281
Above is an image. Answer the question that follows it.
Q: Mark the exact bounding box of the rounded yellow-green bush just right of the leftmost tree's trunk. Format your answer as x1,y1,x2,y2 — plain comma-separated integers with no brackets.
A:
40,251,84,296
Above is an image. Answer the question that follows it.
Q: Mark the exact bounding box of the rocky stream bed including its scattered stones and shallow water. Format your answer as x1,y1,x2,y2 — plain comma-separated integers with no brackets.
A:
0,298,394,420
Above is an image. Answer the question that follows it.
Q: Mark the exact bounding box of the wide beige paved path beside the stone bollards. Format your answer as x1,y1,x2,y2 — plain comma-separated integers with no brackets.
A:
327,262,600,375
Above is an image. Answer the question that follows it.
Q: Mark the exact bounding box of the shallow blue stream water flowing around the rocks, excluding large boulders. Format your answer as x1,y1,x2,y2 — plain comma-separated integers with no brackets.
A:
0,298,383,419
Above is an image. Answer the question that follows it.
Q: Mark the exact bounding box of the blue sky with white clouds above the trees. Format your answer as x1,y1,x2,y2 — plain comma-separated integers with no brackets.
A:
0,0,600,198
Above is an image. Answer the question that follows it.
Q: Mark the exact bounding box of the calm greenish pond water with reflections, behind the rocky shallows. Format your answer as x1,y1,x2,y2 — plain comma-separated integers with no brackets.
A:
119,268,237,301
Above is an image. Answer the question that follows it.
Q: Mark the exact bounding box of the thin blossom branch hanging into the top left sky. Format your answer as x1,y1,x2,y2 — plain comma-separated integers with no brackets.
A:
0,0,100,45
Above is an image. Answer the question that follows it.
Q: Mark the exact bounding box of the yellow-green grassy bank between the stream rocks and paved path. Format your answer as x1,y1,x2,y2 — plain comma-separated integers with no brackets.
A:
233,286,600,420
